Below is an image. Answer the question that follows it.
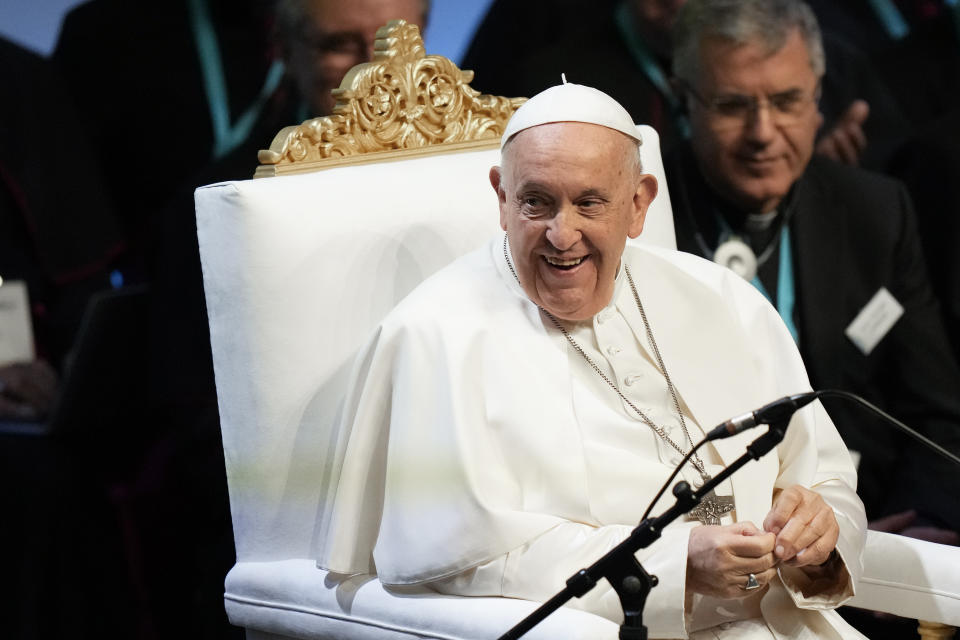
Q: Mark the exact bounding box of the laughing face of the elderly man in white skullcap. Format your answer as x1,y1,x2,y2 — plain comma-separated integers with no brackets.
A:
490,122,657,321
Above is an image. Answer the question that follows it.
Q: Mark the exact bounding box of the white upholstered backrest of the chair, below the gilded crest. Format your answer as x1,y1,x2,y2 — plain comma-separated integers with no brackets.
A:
196,21,675,561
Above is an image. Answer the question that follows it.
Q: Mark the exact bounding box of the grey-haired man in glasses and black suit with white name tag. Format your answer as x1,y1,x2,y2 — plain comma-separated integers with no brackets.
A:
665,0,960,560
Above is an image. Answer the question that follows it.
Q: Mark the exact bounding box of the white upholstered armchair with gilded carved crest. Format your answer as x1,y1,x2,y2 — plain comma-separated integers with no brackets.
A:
196,24,960,640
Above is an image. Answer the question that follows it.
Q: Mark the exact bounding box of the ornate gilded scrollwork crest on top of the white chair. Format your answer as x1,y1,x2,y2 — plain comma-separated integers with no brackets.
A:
257,20,526,175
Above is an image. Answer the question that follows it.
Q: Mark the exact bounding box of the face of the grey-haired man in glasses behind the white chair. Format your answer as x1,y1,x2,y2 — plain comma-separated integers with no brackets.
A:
688,30,821,213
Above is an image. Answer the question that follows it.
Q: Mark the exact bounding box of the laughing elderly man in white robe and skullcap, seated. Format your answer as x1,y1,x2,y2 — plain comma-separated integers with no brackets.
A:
319,84,866,638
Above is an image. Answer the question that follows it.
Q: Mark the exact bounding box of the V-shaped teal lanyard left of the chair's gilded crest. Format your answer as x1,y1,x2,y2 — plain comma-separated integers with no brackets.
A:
187,0,283,160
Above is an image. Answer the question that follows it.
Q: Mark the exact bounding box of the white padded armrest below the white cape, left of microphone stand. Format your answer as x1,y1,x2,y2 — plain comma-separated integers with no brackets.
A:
224,559,619,640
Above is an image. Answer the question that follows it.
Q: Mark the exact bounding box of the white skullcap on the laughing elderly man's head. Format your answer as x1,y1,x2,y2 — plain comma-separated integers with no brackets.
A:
500,82,643,149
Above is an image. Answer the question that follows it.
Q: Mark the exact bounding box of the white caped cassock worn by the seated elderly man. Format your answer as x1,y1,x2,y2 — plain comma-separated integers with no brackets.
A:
318,239,866,638
